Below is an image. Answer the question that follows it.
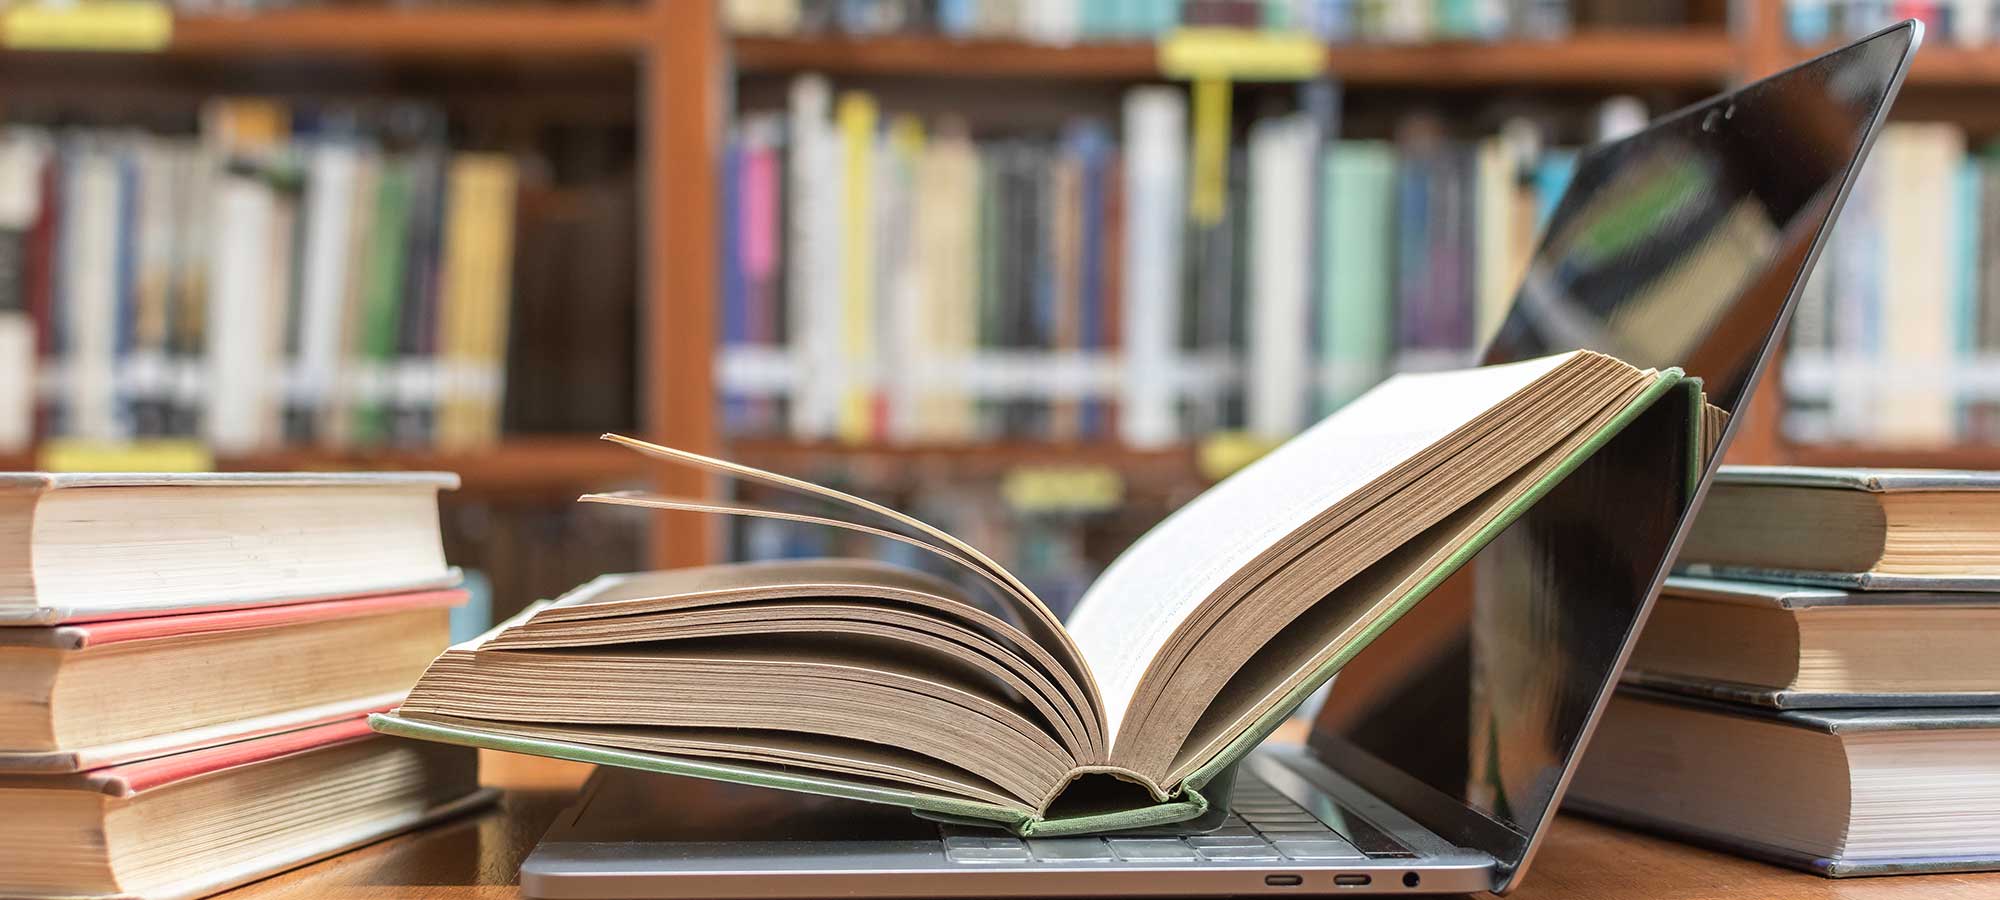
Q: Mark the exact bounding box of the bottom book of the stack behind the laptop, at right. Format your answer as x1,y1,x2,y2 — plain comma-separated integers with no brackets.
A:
1564,688,2000,878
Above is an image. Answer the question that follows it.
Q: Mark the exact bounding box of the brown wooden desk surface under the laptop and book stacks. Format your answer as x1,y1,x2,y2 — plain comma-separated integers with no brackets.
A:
222,754,2000,900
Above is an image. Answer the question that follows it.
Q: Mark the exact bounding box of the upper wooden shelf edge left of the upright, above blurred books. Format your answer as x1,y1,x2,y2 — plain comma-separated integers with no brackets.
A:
10,4,654,58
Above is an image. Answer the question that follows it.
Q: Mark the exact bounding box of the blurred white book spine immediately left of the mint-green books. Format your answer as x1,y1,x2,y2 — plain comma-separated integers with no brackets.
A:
1246,116,1312,440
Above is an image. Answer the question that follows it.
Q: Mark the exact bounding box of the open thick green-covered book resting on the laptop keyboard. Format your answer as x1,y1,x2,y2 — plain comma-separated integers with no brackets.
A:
376,352,1700,834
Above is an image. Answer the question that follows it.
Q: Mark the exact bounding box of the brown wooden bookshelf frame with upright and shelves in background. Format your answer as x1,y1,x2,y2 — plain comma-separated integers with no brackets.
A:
11,0,2000,566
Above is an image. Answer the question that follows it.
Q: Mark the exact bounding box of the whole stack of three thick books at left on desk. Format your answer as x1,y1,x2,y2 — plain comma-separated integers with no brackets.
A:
0,474,484,898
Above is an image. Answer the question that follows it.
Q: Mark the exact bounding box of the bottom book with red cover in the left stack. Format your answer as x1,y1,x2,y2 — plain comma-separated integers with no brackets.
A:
0,718,492,900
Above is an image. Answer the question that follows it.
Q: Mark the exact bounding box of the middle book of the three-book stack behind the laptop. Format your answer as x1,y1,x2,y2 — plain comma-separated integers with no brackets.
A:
1624,576,2000,708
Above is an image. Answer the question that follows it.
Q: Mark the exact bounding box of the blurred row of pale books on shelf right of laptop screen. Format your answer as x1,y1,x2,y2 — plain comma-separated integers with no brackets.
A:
1782,122,2000,446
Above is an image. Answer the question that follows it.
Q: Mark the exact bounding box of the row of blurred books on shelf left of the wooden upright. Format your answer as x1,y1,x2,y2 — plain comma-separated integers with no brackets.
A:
0,100,518,452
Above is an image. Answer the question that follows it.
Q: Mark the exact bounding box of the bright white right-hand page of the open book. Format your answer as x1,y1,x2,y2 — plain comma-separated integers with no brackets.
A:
1068,352,1576,734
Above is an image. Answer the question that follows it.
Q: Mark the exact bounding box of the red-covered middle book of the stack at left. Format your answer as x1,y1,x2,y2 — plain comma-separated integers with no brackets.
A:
0,590,466,772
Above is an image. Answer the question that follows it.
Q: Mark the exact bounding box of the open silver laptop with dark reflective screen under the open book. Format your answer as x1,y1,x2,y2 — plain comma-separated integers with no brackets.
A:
520,20,1922,898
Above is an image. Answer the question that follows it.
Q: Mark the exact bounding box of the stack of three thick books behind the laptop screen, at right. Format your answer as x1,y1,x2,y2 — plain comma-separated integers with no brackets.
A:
1570,466,2000,876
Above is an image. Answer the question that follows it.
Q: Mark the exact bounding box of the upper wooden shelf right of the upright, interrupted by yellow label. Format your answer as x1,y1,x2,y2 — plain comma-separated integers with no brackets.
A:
732,28,1736,88
